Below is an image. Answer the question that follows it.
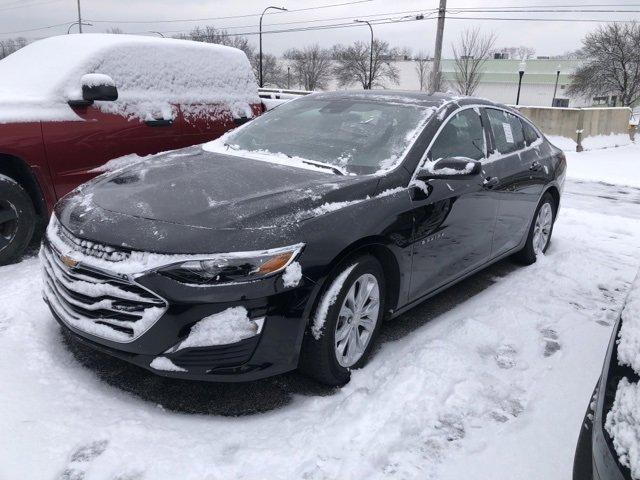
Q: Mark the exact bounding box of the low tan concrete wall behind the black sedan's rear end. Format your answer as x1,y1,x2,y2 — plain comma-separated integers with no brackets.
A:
515,107,631,149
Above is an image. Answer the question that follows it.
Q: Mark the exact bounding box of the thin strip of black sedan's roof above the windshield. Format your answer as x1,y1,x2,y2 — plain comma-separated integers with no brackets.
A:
309,90,504,107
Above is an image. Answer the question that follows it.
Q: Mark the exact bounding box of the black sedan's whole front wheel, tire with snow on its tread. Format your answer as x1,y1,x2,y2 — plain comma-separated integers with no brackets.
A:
299,255,386,386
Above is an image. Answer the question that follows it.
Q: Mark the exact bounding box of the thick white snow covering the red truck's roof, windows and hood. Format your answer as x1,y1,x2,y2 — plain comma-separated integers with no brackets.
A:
0,34,260,123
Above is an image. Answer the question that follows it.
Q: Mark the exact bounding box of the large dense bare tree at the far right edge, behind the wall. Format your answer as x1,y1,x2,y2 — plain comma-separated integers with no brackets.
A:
567,22,640,106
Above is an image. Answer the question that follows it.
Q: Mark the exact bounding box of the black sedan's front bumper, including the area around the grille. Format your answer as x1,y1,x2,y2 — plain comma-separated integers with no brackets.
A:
41,232,317,382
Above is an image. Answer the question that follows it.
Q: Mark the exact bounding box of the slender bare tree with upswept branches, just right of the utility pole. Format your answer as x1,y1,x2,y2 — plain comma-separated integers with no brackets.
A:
452,28,496,95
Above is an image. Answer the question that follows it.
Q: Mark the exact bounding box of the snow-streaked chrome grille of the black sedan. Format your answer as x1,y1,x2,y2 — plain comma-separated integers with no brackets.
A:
40,229,167,342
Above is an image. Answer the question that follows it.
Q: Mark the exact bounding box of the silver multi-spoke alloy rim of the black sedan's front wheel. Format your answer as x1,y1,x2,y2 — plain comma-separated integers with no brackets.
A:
334,273,380,368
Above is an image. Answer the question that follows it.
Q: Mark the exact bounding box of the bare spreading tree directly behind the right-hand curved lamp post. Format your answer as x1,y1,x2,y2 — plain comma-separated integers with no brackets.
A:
333,40,400,88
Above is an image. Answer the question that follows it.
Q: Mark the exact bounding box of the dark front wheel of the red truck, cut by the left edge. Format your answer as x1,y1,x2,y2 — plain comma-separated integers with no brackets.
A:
0,175,37,265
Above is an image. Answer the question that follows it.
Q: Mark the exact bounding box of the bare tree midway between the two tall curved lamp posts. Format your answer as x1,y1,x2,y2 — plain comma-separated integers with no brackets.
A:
284,44,332,90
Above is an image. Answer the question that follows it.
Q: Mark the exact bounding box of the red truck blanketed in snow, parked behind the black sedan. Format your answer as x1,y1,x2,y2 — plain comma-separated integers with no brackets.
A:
0,34,263,265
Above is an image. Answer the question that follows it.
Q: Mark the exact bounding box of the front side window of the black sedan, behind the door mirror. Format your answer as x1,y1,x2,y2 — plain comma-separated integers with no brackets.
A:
429,108,486,160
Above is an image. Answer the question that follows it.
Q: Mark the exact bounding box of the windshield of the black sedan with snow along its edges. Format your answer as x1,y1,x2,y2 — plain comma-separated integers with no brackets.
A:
218,98,432,174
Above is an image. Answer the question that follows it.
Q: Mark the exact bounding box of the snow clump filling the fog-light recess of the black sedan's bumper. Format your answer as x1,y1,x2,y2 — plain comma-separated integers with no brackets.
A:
171,307,259,352
